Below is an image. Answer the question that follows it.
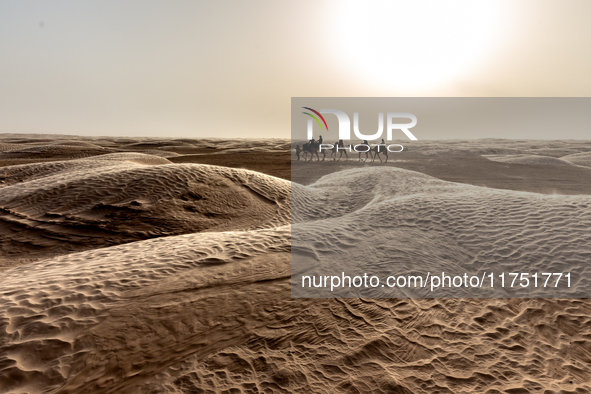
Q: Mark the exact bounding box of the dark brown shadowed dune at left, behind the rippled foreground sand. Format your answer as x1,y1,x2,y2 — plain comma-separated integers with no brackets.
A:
0,153,290,268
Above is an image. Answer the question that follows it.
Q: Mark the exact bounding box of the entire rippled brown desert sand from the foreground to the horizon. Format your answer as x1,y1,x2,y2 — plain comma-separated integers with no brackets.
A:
0,135,591,394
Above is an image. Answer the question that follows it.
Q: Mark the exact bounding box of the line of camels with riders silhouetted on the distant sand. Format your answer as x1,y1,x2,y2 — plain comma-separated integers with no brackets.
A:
296,136,402,163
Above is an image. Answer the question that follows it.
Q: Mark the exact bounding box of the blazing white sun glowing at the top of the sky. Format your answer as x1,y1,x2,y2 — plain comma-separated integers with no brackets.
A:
330,0,506,90
